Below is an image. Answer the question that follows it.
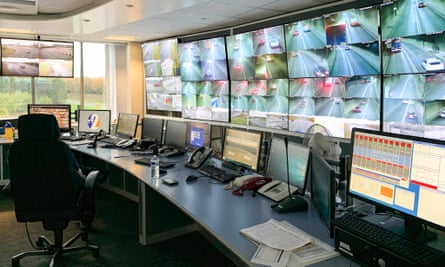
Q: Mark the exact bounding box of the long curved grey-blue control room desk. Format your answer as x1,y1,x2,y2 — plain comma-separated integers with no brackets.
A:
72,145,354,266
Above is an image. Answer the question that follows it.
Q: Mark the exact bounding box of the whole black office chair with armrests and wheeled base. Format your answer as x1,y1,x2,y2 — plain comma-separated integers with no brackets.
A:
9,114,99,266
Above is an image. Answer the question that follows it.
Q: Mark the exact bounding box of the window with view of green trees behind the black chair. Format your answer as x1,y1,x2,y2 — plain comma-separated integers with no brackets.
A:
0,42,116,118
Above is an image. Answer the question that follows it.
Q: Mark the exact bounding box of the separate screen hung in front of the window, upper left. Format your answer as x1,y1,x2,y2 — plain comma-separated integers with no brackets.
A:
0,38,74,77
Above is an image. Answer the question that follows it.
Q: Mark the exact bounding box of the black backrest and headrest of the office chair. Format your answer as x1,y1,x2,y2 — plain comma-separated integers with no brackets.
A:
9,114,82,222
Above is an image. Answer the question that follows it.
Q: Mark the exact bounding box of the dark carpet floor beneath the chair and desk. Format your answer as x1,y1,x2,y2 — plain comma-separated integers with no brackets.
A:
0,186,235,267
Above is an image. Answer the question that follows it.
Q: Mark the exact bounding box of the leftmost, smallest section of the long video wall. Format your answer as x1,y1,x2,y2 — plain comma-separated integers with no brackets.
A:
142,39,182,111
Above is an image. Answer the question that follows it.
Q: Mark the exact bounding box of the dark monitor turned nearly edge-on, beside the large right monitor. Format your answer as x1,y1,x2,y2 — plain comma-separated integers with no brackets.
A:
310,152,336,237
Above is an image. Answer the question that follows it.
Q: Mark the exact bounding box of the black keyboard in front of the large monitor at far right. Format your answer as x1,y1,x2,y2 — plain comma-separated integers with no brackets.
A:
333,214,445,266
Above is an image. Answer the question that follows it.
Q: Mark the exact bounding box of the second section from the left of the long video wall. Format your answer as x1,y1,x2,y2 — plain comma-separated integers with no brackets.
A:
179,37,229,122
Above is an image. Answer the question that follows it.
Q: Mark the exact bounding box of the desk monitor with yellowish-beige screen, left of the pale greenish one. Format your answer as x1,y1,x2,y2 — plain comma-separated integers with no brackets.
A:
222,128,262,171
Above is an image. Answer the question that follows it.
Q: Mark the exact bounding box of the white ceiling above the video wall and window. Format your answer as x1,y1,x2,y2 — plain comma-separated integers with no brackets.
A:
0,0,355,42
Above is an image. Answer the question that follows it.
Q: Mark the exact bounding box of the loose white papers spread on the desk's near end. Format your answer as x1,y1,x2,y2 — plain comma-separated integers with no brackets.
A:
240,219,339,267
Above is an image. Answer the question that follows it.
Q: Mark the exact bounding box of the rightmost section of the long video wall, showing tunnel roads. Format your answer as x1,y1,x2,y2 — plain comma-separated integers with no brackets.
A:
381,0,445,139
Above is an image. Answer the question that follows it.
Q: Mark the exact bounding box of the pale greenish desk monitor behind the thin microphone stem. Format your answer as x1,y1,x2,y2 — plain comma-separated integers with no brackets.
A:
267,136,310,195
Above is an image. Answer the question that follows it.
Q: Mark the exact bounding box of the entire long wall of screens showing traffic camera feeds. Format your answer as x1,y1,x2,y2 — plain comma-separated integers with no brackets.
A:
142,0,445,139
